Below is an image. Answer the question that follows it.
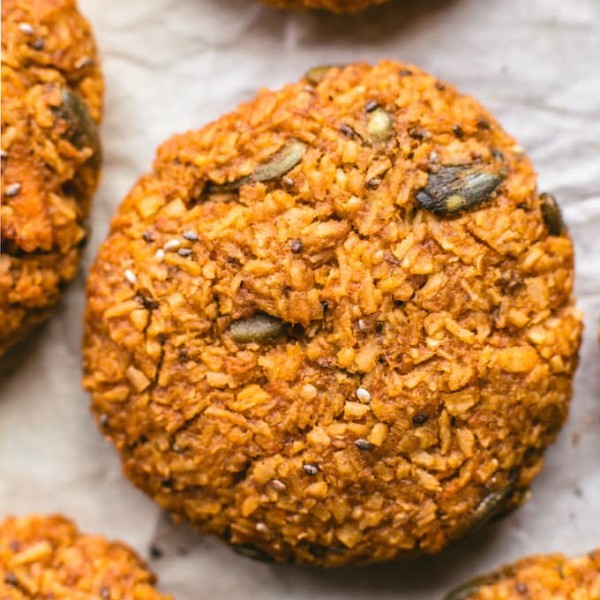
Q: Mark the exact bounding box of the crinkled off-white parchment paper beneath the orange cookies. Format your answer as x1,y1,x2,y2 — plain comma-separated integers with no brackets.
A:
0,0,600,600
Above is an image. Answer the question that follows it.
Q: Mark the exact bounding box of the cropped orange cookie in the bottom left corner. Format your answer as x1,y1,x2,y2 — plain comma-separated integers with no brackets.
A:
0,515,172,600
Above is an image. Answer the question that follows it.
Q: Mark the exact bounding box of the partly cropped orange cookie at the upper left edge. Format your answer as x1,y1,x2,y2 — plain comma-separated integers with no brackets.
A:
0,0,103,354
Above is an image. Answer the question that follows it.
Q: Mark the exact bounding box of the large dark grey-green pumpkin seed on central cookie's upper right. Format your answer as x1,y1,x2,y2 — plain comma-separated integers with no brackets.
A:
416,165,505,215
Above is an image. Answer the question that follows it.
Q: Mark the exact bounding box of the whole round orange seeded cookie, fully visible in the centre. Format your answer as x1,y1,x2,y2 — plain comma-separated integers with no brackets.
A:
84,62,581,566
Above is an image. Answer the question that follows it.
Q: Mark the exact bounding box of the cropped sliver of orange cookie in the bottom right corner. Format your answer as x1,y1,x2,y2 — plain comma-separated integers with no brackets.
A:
444,550,600,600
